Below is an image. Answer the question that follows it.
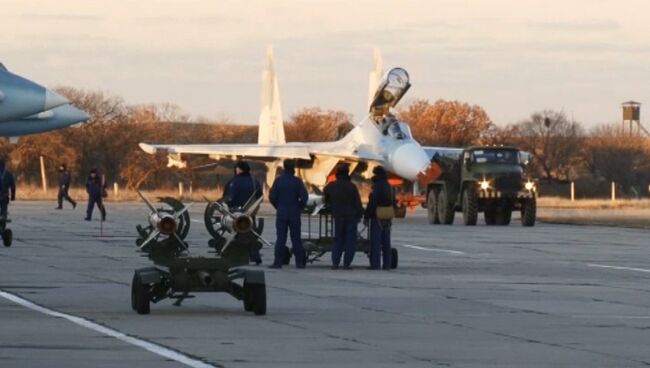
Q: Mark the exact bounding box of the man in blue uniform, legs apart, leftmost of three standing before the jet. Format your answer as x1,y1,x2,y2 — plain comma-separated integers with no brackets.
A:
269,160,308,268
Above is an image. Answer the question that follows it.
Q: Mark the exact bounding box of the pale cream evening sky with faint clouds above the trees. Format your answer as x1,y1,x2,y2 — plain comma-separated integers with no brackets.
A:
0,0,650,127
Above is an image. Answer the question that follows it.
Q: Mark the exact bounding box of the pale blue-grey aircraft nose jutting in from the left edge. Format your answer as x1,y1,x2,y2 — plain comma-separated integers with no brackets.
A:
0,64,89,137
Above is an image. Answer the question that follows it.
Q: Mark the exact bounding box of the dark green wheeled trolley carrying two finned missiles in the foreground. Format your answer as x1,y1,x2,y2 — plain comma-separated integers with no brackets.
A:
131,192,266,315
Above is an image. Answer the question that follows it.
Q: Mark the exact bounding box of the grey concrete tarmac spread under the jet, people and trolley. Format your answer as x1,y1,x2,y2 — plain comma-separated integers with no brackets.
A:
0,202,650,368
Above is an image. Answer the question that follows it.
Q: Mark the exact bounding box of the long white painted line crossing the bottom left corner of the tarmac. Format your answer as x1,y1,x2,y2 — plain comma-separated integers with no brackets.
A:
0,290,217,368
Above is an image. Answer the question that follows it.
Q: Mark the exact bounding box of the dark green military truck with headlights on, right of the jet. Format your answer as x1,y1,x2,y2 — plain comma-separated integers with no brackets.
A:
425,146,537,226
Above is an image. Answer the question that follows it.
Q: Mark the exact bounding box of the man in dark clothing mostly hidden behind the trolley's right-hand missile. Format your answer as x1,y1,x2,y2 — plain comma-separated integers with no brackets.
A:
223,161,264,265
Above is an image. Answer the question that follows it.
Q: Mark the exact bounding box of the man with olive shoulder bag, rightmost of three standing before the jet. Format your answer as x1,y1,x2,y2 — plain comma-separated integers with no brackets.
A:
364,166,395,270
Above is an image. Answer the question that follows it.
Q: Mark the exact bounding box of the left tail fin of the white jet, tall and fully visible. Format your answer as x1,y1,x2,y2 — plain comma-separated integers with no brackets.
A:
257,46,286,144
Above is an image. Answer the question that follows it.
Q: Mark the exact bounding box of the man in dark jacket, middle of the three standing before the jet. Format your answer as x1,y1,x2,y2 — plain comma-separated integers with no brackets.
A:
324,165,363,270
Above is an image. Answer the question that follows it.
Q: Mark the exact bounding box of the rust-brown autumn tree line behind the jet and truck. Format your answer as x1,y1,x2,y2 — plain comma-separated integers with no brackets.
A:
6,88,650,195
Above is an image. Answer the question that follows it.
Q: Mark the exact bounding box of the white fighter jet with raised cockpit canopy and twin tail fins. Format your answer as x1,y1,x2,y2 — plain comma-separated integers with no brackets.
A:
140,48,445,196
